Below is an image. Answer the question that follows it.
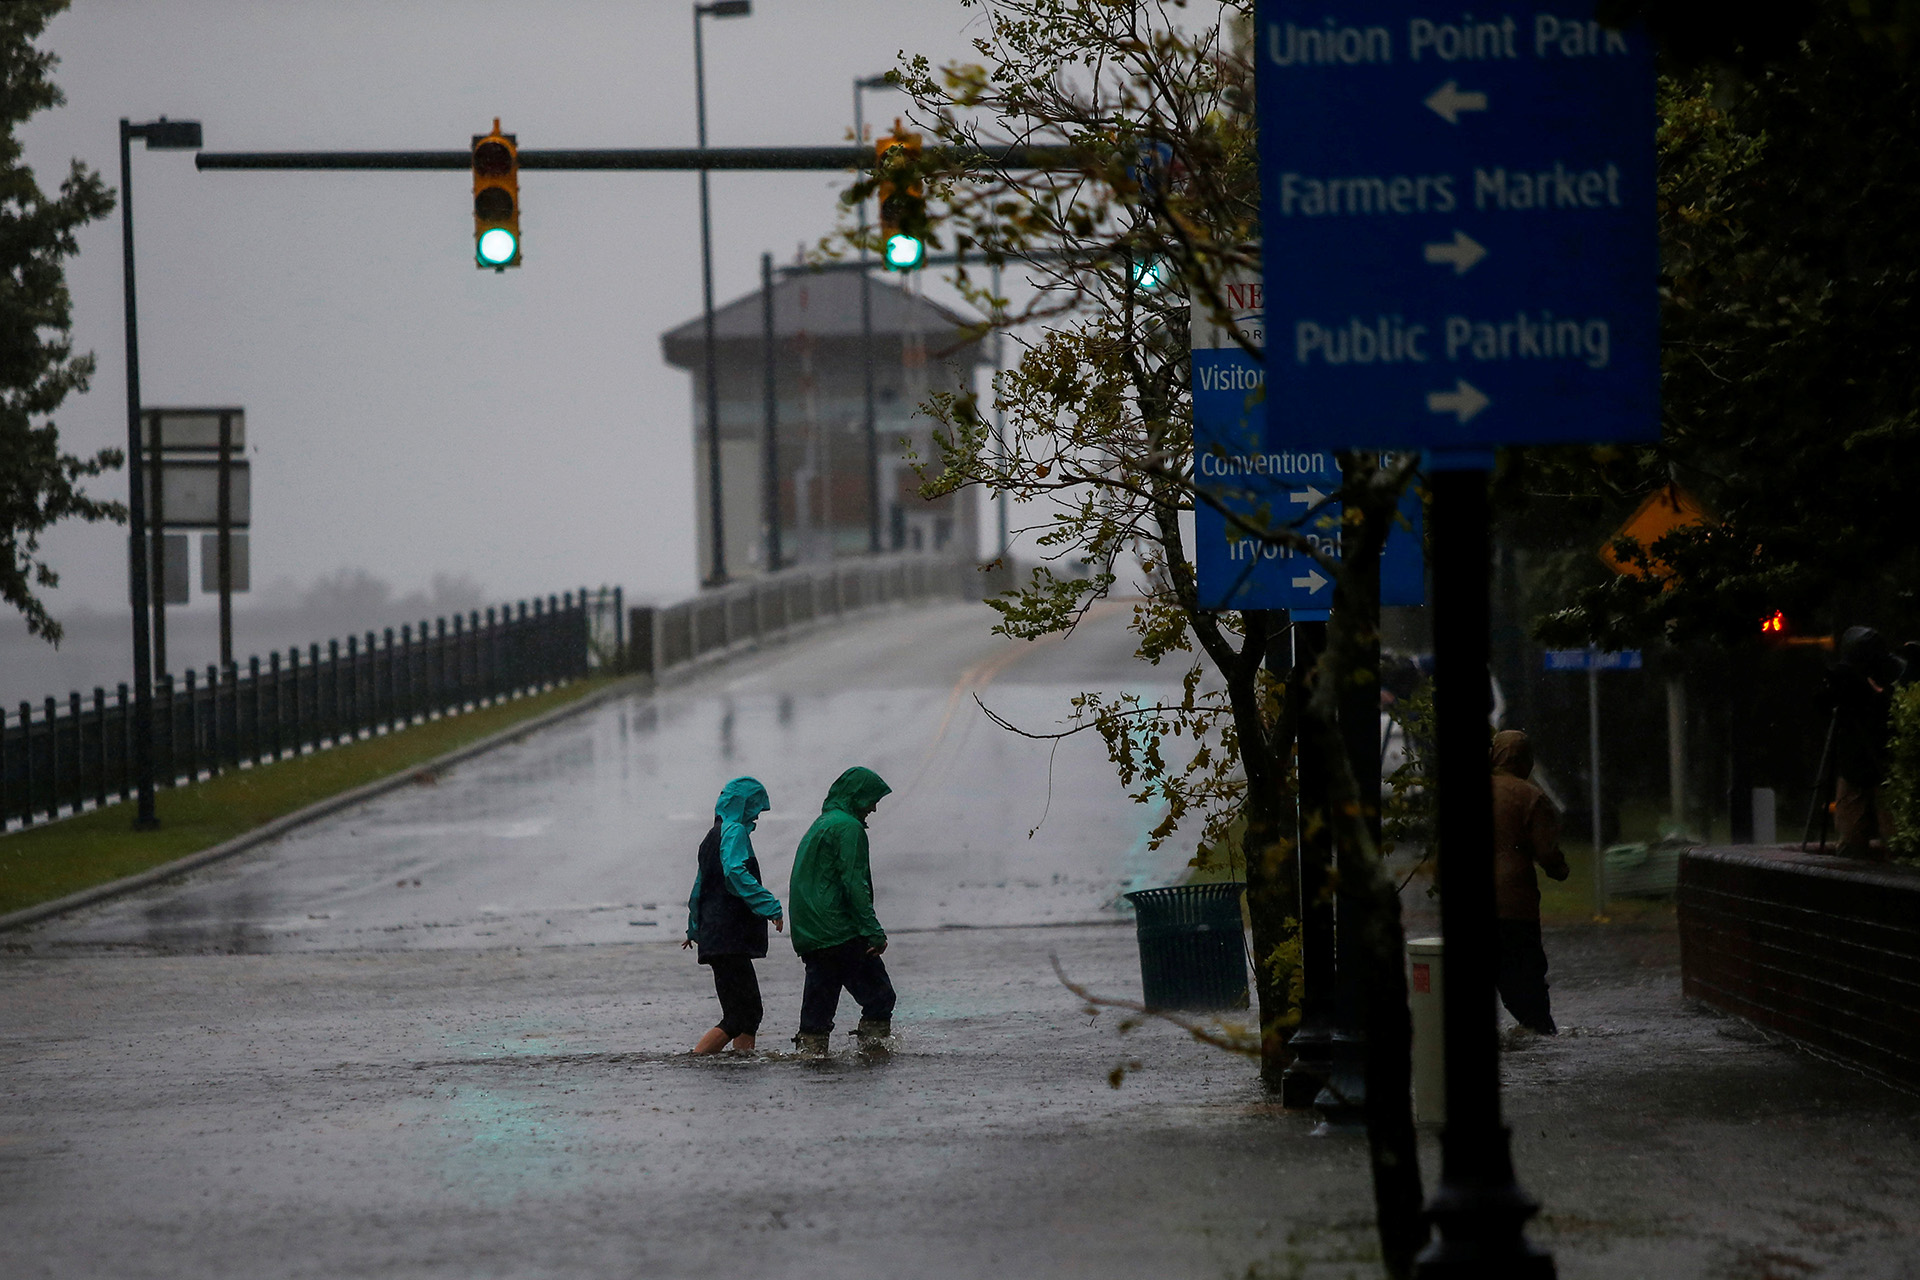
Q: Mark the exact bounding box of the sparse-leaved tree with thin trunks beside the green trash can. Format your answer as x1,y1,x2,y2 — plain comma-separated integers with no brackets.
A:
867,0,1425,1276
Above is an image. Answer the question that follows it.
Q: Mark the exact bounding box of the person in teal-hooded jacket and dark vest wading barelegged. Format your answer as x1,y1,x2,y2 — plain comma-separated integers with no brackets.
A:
680,777,783,1054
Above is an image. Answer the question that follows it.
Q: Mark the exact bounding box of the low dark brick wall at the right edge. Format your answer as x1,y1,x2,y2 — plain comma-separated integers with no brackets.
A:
1680,846,1920,1084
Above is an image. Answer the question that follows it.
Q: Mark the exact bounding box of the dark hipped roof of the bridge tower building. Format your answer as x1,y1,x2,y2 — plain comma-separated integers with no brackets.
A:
660,271,987,368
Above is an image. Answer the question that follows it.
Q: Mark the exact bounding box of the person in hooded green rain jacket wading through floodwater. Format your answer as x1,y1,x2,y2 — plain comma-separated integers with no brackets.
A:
787,766,895,1054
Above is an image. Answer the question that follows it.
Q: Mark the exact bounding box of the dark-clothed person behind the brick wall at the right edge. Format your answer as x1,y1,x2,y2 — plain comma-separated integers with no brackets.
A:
1828,628,1908,860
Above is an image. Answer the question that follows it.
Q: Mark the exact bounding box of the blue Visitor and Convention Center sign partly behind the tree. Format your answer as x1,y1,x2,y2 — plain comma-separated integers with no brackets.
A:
1190,278,1427,614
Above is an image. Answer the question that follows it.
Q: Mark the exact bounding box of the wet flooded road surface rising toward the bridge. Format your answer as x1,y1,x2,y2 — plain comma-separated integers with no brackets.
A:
0,608,1920,1280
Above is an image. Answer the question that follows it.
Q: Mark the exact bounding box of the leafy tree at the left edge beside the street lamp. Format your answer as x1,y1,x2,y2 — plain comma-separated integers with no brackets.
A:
0,0,125,643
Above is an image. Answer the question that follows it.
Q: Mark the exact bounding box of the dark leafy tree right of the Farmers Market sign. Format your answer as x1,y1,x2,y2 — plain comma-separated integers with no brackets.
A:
1528,0,1920,651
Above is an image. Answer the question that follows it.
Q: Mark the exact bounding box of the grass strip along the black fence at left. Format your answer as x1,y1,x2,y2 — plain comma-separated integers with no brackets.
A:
0,677,609,915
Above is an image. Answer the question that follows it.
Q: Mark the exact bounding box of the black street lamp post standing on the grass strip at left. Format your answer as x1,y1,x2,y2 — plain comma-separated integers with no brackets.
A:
121,115,200,831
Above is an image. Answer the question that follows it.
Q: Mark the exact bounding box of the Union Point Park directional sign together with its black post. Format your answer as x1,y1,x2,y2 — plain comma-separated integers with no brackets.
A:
1254,0,1659,1280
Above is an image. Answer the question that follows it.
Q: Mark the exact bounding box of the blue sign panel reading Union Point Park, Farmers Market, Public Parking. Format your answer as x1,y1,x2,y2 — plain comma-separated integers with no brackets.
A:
1256,0,1659,451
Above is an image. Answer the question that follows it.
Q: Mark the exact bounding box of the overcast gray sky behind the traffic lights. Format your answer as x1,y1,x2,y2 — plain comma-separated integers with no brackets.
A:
23,0,991,612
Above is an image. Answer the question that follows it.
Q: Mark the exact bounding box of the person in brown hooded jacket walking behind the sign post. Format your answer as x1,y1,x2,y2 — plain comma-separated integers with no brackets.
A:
1490,729,1566,1036
